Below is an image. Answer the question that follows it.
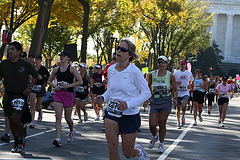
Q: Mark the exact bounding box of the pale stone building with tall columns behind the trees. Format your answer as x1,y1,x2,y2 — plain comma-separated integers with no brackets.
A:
208,0,240,73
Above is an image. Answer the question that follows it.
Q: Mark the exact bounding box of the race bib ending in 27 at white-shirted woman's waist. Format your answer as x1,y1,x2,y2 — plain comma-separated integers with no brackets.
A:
106,99,122,118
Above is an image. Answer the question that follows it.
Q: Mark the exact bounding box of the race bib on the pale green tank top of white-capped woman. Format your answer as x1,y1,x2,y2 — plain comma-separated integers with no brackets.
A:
152,83,169,98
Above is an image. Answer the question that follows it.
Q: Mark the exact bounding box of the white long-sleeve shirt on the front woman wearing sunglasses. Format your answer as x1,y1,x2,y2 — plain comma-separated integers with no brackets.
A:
102,63,151,115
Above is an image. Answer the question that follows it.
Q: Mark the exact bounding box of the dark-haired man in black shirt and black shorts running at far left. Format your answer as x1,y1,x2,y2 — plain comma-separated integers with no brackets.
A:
0,41,38,152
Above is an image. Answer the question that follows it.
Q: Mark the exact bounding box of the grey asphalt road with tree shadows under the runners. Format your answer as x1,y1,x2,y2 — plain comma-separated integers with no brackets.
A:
0,95,240,160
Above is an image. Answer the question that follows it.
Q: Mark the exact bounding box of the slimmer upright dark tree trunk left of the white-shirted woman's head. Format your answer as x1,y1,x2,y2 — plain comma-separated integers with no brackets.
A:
78,0,90,63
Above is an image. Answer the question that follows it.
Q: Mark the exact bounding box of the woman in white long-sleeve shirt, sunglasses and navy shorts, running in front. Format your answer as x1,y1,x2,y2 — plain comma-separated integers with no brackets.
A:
97,39,151,160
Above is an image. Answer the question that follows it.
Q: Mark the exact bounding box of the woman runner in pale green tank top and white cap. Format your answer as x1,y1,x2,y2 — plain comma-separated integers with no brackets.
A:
145,56,178,153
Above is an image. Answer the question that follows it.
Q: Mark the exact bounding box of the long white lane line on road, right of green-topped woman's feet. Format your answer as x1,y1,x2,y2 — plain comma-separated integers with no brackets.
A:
157,110,205,160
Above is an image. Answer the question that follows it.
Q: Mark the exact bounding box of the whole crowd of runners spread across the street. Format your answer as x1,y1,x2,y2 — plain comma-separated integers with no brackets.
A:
0,39,239,160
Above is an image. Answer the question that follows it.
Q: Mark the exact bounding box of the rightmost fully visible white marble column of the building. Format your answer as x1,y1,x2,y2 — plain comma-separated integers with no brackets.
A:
224,14,234,61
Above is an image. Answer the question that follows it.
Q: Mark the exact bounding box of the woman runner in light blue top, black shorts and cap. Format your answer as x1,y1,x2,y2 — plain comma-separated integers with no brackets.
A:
192,69,208,126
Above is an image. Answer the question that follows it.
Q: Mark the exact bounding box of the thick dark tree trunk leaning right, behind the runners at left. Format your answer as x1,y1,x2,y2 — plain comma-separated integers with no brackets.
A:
29,0,54,55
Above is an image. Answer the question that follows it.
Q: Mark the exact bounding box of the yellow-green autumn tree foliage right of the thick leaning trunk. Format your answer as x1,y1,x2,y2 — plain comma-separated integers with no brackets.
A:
0,0,213,69
